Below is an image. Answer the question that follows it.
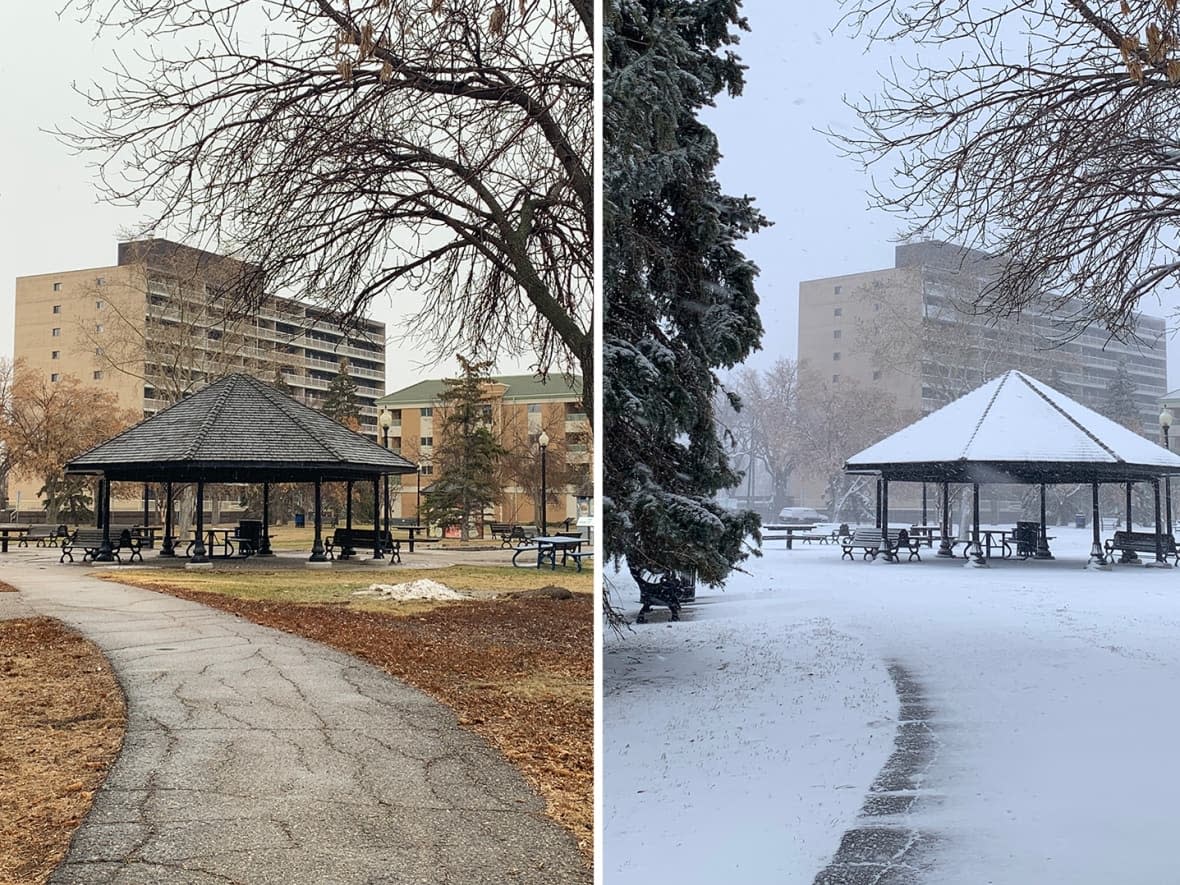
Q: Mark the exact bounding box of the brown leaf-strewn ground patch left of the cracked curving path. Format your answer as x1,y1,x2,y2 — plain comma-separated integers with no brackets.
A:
0,618,125,885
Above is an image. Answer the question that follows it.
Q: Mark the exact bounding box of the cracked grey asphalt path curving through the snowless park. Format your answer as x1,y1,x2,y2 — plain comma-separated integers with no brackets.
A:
0,553,591,885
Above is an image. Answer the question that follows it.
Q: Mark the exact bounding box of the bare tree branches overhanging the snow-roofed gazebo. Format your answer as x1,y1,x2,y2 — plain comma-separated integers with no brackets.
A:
841,0,1180,337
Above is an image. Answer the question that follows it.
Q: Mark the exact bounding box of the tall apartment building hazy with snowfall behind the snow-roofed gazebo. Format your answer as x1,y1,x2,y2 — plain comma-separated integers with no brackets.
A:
799,242,1167,506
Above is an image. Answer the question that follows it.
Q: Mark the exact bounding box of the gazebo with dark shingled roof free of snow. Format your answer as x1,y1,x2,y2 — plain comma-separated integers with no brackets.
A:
66,374,417,563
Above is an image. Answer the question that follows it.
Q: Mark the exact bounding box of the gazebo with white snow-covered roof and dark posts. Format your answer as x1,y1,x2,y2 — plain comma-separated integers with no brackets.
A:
844,369,1180,568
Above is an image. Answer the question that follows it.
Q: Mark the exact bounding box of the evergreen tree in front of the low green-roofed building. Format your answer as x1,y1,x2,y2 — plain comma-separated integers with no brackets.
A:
421,356,504,540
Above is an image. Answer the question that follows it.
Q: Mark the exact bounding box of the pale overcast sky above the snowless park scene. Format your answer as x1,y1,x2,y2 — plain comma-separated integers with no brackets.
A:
0,0,529,391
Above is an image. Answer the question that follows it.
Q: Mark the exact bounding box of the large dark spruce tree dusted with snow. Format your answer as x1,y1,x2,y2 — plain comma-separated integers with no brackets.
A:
603,0,766,604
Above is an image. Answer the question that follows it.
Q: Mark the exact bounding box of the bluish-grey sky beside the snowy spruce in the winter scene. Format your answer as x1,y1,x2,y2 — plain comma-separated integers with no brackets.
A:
707,0,1180,388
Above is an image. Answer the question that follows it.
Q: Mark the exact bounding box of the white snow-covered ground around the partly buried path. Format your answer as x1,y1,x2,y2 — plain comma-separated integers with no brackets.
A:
603,527,1180,885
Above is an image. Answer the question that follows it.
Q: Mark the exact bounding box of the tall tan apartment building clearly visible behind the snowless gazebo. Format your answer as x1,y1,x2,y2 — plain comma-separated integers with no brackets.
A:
9,240,385,502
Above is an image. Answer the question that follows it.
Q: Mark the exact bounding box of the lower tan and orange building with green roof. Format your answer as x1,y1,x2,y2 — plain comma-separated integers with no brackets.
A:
376,375,594,524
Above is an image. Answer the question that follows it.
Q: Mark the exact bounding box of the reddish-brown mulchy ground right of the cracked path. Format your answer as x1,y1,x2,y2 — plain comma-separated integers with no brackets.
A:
135,581,595,864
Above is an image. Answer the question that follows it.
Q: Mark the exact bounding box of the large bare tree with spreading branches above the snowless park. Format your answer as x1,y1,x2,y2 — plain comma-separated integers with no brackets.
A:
65,0,594,402
